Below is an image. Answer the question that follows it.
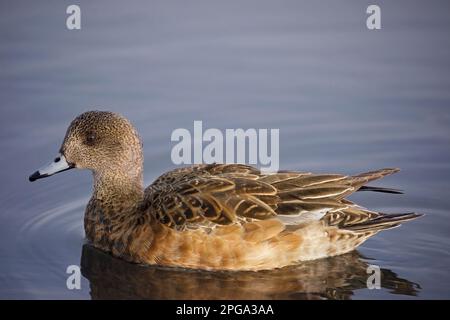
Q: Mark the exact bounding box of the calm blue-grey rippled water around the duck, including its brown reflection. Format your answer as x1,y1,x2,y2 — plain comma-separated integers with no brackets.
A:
0,0,450,299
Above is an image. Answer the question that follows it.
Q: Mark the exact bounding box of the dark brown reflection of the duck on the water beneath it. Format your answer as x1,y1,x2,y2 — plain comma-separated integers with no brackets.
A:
81,244,420,300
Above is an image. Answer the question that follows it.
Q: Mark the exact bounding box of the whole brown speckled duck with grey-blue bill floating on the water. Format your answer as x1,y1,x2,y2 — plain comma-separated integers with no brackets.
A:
29,111,421,271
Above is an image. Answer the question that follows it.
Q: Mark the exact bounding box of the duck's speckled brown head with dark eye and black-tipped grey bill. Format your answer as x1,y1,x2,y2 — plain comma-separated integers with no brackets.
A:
30,111,143,181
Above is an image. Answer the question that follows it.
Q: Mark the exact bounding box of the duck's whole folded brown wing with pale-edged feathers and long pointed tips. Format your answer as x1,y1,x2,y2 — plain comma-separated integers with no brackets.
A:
144,164,398,230
